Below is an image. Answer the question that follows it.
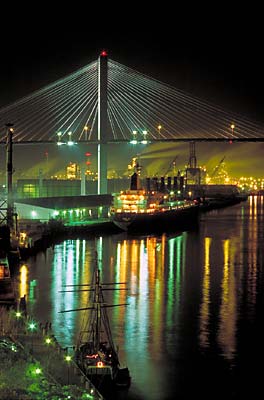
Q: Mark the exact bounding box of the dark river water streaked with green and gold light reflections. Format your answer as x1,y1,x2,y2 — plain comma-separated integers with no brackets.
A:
13,196,264,400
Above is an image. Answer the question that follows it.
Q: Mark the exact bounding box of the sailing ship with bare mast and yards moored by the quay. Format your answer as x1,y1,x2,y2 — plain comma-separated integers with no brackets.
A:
60,257,131,394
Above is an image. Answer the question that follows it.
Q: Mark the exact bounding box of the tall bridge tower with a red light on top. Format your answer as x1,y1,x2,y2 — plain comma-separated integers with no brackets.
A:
97,50,108,194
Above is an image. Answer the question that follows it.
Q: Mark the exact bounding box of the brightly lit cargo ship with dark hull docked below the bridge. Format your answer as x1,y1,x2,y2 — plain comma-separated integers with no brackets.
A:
111,164,199,233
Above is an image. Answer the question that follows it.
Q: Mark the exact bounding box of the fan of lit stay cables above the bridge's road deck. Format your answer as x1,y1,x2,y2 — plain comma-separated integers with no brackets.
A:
0,53,264,144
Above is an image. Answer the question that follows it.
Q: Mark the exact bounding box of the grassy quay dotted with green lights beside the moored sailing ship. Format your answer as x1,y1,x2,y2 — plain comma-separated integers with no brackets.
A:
0,308,104,400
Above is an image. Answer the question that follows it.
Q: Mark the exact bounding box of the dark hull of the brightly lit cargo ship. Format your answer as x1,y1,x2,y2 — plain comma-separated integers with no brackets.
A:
112,206,199,233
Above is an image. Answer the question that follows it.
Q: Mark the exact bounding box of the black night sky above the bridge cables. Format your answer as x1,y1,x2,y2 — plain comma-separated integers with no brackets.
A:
0,6,264,178
